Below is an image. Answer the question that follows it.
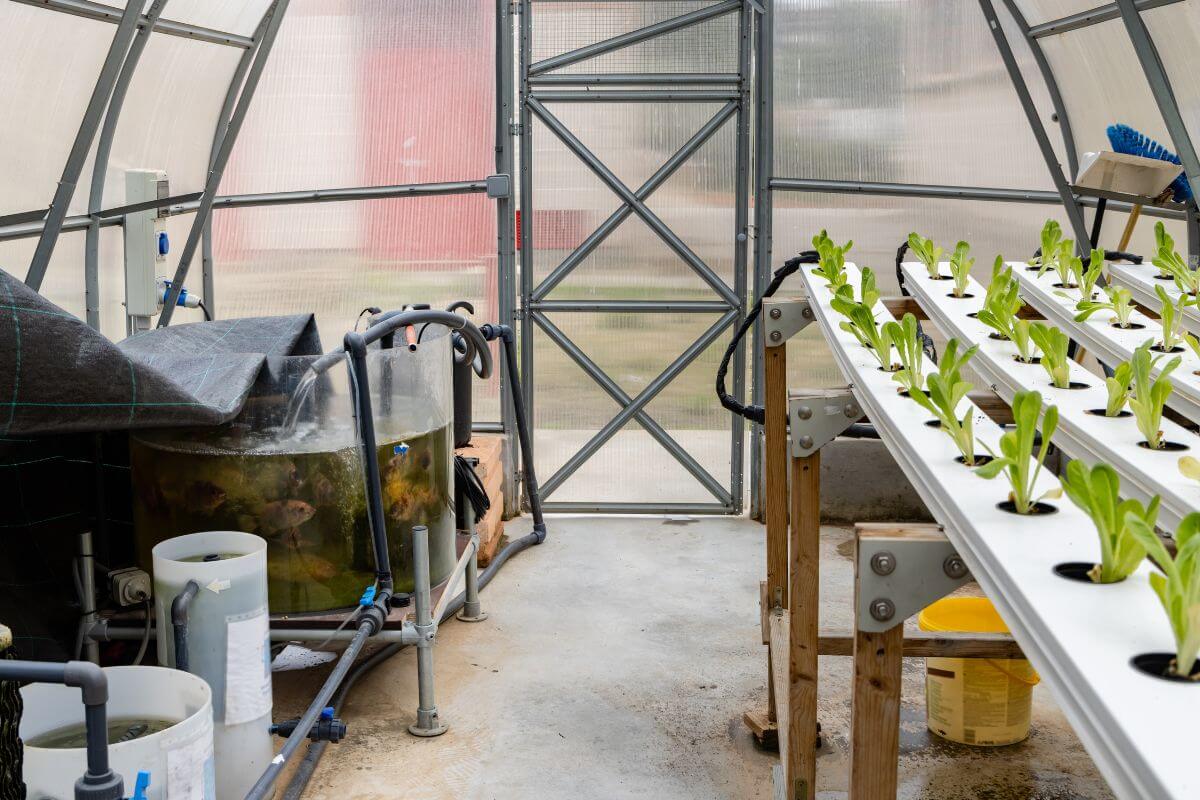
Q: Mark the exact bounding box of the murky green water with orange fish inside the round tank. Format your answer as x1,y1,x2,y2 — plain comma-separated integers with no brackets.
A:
130,417,456,614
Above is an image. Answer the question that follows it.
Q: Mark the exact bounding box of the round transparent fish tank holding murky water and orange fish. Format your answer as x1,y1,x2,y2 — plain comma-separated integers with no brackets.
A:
130,325,456,614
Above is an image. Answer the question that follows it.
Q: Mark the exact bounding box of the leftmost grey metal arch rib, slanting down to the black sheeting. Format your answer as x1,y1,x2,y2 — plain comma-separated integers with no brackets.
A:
25,0,143,291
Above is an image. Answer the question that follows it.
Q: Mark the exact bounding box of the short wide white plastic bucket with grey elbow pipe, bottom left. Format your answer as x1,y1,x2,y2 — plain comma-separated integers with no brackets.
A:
20,667,213,800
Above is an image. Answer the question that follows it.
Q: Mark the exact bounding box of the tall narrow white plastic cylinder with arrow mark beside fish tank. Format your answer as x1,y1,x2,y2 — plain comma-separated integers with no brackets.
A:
154,530,275,800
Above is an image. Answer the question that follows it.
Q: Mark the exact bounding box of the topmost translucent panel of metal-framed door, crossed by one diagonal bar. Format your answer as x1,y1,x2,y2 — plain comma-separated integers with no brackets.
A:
532,1,738,74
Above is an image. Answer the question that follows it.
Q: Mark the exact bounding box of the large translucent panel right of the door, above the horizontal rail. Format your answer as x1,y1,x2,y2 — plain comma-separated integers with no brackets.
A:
774,0,1058,188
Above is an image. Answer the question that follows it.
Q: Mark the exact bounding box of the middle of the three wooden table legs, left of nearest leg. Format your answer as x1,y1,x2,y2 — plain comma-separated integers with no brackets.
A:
784,451,821,800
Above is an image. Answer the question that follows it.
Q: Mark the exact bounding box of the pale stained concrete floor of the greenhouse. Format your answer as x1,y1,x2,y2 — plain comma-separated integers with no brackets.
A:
276,517,1111,800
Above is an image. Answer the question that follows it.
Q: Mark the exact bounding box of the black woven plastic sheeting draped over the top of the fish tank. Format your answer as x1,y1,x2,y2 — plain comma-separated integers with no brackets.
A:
0,270,322,439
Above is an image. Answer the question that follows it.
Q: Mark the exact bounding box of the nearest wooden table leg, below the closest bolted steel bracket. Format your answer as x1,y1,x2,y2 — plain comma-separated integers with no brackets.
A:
850,532,904,800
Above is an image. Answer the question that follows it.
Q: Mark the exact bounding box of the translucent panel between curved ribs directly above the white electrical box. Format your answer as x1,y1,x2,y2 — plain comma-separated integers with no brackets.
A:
96,35,242,209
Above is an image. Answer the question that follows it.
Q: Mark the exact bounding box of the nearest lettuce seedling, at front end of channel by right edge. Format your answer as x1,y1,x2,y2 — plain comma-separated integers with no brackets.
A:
1126,511,1200,678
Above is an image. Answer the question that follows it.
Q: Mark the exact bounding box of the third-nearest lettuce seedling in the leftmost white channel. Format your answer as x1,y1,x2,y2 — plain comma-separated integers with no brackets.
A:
976,391,1062,513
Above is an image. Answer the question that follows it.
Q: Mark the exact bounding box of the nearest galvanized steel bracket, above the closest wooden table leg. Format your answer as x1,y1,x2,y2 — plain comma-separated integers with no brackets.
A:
856,525,971,633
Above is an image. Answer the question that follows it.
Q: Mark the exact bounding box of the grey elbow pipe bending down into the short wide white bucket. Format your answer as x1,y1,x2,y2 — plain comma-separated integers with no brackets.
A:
0,660,125,800
